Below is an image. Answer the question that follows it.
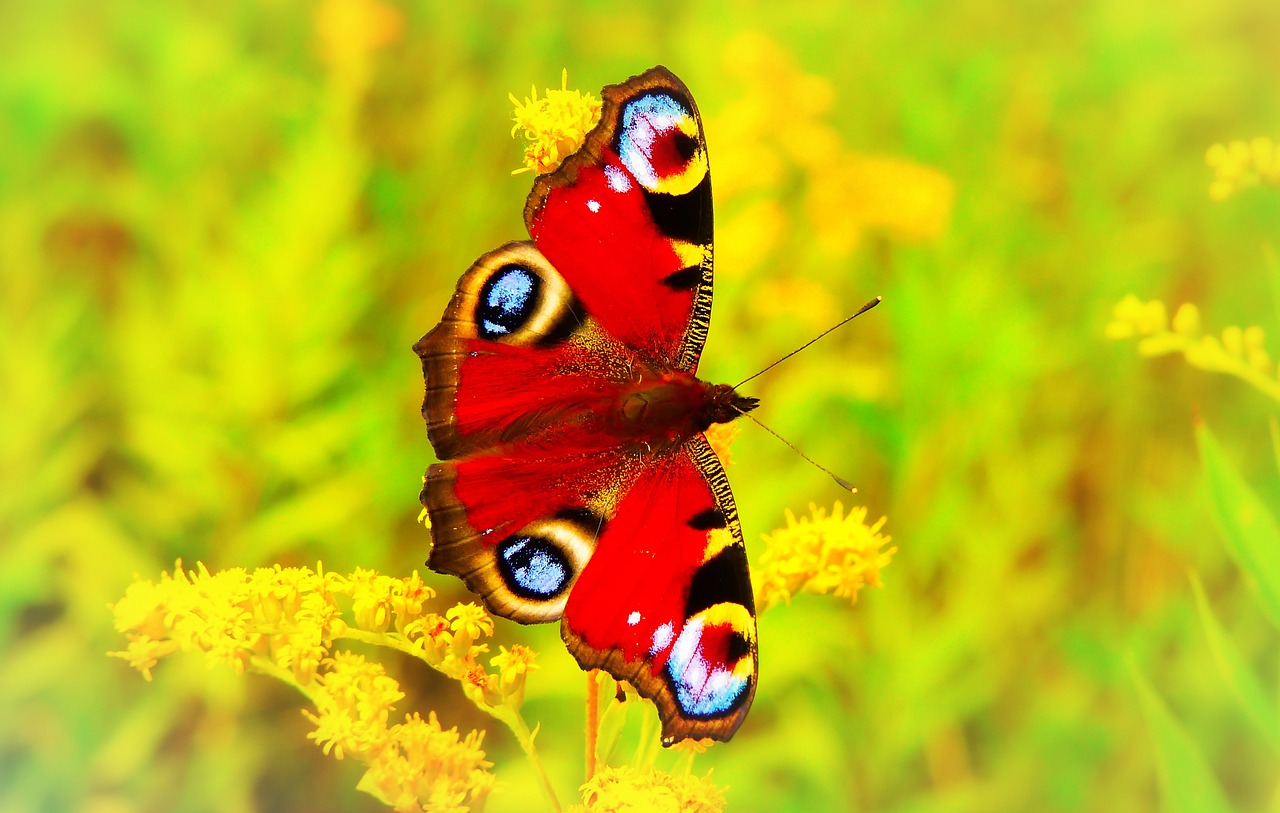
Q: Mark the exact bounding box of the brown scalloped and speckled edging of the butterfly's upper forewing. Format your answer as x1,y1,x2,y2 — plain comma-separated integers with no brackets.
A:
525,65,714,373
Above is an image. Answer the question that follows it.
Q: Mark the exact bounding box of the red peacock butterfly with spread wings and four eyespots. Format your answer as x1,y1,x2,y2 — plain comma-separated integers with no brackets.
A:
413,67,758,745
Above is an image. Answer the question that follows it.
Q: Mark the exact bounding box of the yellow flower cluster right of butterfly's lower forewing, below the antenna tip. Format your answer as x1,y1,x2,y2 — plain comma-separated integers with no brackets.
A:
753,502,897,611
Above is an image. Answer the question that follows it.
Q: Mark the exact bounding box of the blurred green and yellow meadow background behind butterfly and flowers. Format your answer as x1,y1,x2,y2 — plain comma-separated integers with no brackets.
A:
0,0,1280,813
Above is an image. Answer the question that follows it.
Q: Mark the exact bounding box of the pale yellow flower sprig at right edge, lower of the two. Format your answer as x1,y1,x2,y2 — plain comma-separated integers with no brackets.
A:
1107,294,1280,401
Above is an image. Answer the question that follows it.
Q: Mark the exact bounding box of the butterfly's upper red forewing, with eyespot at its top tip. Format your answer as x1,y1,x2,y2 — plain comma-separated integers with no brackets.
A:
525,68,712,373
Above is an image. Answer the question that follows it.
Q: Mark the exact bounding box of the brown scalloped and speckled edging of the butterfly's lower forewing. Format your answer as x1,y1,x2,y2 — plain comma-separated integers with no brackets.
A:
561,433,760,746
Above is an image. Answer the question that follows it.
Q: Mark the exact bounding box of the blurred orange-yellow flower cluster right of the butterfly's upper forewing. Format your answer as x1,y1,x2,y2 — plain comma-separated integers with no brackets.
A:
707,32,955,270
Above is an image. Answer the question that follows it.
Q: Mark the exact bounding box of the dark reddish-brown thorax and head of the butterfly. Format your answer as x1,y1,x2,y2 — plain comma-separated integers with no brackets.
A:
613,373,759,443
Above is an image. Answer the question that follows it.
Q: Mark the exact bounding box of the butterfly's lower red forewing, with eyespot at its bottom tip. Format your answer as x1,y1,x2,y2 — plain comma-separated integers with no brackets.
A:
561,434,756,744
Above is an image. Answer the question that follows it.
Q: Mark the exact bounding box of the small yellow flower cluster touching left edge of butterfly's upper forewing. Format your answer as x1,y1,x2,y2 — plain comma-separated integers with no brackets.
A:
509,69,600,175
